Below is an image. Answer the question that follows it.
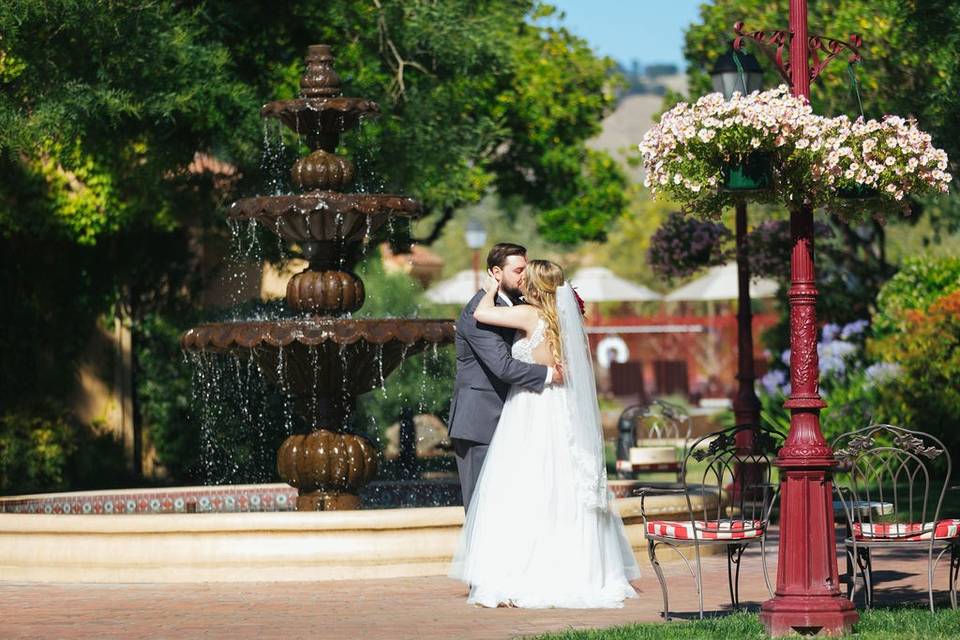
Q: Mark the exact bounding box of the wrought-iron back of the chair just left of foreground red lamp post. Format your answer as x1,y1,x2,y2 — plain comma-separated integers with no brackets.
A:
683,425,783,532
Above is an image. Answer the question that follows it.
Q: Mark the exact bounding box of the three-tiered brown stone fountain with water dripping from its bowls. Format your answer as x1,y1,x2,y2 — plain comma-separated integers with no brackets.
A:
181,45,454,511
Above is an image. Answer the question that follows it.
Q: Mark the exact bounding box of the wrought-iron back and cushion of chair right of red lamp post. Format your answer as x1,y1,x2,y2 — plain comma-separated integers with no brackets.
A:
834,424,951,541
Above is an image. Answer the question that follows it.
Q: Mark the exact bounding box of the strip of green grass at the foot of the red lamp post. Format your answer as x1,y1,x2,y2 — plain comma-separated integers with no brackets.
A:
530,608,960,640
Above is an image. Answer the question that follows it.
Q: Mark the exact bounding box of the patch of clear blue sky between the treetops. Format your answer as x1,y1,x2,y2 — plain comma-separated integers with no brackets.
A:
547,0,703,67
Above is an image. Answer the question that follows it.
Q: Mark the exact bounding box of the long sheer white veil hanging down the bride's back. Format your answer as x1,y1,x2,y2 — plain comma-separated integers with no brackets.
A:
557,283,609,511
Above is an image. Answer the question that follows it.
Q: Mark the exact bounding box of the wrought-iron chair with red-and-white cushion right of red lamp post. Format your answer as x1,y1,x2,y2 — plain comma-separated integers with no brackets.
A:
833,424,960,612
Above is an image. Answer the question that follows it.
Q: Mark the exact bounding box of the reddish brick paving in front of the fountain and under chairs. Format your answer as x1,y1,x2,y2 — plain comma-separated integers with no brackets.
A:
0,532,946,640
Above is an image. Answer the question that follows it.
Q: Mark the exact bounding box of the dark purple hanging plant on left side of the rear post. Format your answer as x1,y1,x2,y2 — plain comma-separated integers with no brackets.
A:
647,212,736,278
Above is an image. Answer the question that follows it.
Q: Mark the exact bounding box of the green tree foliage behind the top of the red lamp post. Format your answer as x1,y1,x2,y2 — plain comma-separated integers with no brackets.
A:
684,0,960,226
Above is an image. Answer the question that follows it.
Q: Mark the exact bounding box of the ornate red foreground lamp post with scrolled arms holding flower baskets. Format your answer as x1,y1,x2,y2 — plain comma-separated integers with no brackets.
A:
734,0,860,635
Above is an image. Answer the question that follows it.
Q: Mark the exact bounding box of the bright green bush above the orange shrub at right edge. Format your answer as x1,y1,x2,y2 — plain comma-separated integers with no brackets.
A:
873,256,960,339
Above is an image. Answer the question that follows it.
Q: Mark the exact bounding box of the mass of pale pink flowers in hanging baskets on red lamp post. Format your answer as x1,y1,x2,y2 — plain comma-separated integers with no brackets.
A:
640,86,952,218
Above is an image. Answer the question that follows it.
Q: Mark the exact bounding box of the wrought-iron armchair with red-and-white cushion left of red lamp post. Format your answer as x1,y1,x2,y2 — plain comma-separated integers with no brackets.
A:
637,426,783,620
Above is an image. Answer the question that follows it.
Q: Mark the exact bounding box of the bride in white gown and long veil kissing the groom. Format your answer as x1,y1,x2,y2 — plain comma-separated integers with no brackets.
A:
450,260,640,608
